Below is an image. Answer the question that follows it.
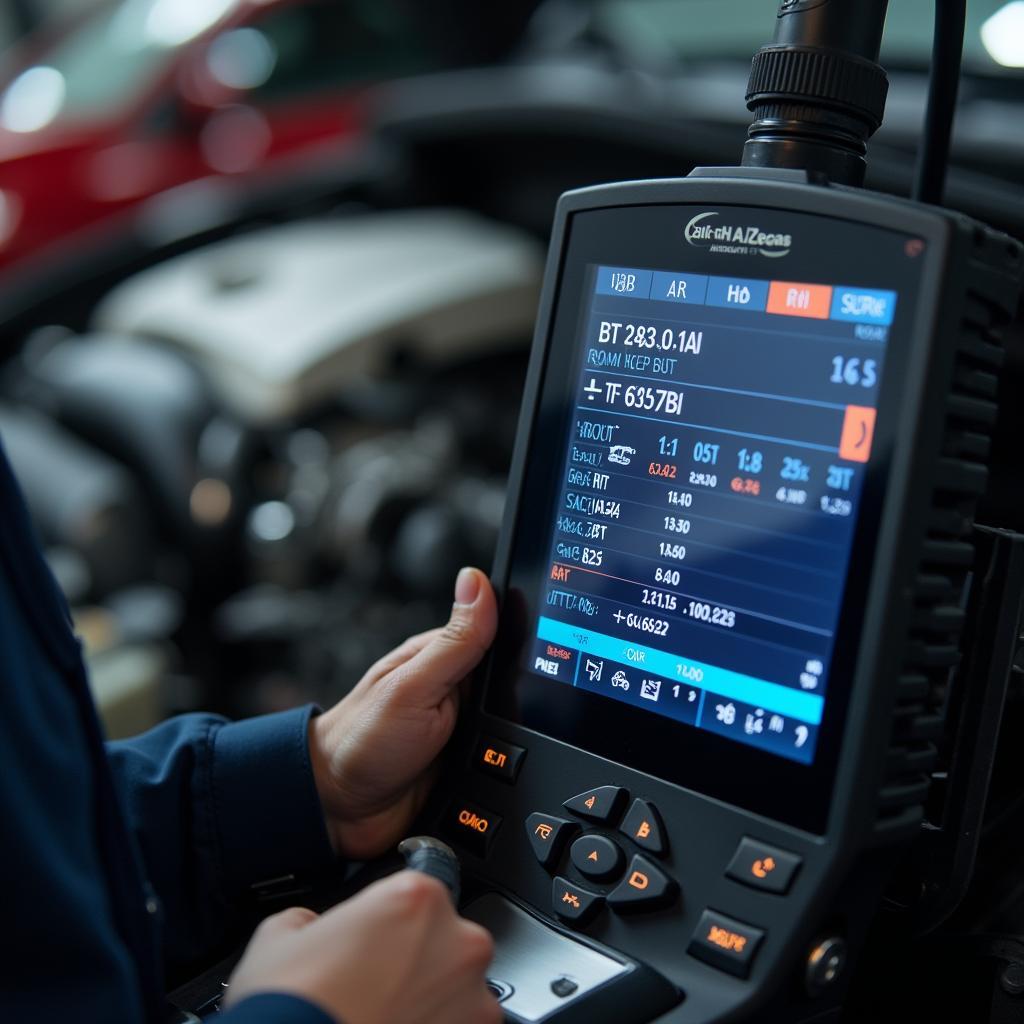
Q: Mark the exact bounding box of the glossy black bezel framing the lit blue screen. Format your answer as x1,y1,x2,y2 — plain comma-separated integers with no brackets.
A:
483,183,930,834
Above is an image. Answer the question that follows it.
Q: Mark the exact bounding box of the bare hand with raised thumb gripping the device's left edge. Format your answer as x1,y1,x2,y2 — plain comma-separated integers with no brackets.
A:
309,568,498,860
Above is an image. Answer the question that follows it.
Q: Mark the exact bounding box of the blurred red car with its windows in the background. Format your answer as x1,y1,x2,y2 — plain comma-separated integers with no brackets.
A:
0,0,437,268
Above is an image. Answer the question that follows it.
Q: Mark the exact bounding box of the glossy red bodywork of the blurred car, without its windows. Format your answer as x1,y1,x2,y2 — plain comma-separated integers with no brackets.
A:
0,0,372,270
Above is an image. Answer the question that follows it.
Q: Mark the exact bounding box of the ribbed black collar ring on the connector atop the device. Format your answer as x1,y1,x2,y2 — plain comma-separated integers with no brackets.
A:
746,44,889,135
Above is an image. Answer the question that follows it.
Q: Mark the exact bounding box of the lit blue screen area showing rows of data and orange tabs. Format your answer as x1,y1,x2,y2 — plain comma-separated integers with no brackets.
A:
527,266,896,764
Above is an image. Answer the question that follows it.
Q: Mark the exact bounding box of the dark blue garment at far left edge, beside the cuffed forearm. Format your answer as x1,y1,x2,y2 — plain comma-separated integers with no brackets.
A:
0,581,147,1024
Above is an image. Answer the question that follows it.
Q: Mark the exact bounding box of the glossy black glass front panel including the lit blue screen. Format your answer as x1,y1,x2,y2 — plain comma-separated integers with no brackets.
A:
488,201,922,827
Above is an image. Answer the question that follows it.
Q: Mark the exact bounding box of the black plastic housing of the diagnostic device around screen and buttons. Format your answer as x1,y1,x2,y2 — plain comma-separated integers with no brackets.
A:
423,168,1024,1024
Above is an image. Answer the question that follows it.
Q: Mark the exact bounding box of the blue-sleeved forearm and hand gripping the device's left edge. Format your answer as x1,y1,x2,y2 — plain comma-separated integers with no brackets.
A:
108,569,497,964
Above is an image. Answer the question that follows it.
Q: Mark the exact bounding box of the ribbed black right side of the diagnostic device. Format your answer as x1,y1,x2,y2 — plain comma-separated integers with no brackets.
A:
876,218,1024,836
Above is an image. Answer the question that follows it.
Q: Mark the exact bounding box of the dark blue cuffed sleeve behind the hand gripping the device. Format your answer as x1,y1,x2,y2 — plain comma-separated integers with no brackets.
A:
108,707,334,964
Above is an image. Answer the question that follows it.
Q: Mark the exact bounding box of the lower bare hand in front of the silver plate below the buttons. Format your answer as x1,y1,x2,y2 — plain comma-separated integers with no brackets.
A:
225,871,503,1024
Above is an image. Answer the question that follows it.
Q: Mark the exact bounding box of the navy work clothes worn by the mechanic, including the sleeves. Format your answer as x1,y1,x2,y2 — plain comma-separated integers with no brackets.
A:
0,449,332,1024
